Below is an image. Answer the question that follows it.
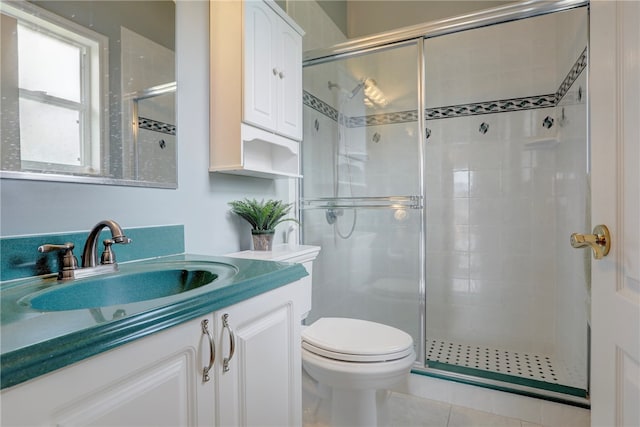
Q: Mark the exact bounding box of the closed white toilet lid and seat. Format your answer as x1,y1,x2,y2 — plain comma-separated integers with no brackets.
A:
302,317,413,362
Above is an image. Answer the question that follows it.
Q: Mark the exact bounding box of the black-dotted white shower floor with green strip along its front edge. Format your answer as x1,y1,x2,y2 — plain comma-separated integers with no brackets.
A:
425,338,587,400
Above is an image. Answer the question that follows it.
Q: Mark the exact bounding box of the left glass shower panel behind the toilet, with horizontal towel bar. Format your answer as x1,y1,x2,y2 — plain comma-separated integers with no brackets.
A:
300,42,424,355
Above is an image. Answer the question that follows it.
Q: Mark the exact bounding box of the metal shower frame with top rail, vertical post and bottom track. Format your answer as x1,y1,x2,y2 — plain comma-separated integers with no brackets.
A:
298,0,590,408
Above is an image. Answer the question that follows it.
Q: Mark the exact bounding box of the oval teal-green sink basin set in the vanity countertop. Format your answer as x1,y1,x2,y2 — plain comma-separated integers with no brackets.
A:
20,263,237,311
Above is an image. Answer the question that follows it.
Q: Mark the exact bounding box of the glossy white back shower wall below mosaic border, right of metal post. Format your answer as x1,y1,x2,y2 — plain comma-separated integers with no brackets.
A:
425,109,555,353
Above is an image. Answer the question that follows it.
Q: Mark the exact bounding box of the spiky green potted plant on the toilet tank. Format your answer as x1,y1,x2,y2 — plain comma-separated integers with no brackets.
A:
229,198,298,251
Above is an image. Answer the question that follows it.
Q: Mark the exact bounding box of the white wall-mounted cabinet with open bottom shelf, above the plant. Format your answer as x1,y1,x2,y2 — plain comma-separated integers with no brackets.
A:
209,0,303,177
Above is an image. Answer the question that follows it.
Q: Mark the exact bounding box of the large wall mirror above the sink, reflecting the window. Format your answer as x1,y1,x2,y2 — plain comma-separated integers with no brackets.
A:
0,0,177,188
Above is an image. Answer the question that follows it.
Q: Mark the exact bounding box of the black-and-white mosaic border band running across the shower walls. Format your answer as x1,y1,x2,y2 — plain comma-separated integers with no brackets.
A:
302,47,587,127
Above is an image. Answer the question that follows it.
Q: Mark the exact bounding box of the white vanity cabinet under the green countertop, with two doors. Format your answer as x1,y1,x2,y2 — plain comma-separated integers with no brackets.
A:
0,281,310,427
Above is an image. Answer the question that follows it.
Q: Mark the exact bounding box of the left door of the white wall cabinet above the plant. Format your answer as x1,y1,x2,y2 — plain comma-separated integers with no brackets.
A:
243,0,280,131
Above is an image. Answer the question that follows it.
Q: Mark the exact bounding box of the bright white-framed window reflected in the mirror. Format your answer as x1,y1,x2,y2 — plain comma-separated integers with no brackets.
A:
1,2,108,175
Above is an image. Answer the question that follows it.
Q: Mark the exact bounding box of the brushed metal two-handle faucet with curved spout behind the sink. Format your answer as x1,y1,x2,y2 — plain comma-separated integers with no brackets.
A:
38,219,131,280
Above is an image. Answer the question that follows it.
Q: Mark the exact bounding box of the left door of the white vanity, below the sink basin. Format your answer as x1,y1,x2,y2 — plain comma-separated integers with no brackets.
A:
1,319,215,426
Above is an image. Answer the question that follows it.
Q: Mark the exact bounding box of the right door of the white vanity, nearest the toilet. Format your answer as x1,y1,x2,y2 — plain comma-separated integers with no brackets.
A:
216,283,301,427
